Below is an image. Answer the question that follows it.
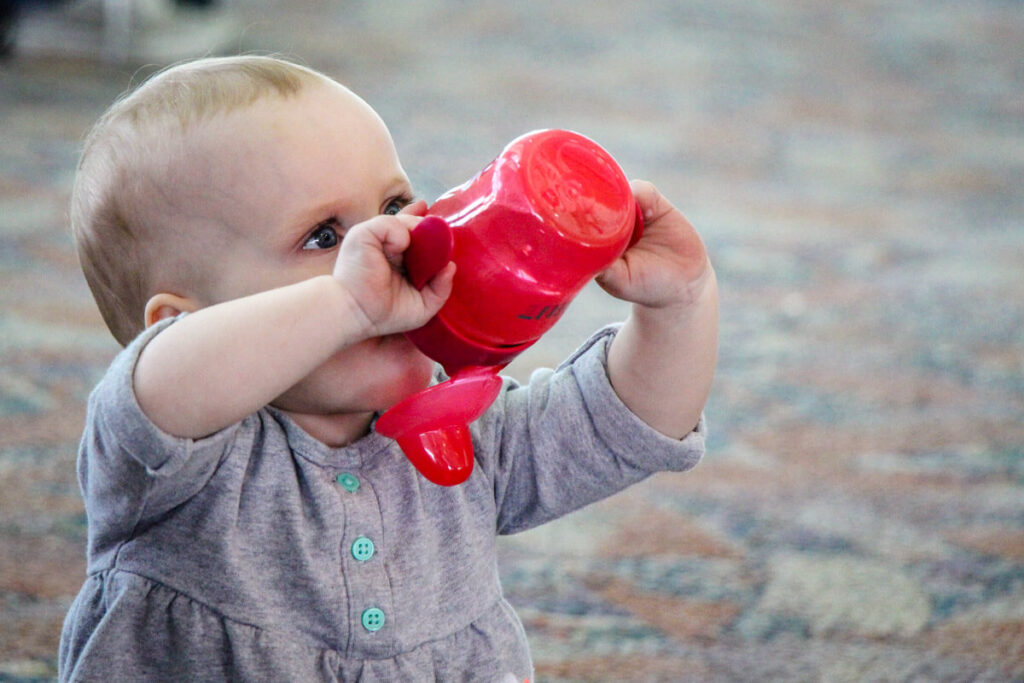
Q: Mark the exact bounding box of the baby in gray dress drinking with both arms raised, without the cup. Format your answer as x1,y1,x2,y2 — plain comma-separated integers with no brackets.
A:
59,56,718,681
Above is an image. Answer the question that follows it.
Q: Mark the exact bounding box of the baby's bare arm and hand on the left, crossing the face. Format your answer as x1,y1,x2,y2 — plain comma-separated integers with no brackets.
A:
134,213,455,438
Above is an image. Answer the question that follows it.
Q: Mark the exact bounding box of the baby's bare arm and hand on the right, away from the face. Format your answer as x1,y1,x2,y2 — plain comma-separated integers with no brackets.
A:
598,181,718,438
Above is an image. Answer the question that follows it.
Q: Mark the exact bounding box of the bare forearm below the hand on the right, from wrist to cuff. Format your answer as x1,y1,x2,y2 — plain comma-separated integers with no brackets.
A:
608,268,718,438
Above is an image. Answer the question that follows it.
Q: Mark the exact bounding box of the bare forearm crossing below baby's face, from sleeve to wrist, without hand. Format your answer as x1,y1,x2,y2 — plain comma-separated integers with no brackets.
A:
134,275,365,438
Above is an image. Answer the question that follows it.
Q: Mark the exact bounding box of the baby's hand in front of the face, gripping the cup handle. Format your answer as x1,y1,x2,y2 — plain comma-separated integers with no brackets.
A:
334,212,455,338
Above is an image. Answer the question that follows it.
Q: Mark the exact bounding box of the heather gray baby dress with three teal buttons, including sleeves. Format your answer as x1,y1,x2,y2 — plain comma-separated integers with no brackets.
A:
59,322,705,681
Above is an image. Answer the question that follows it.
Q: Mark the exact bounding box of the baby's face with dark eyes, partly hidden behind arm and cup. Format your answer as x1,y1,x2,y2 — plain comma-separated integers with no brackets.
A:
176,84,432,415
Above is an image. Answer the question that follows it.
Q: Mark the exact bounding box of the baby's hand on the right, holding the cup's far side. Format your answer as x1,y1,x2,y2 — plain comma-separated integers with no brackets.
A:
597,180,712,308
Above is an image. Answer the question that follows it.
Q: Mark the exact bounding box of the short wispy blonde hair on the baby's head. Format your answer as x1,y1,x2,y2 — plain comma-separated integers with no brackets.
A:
71,55,331,345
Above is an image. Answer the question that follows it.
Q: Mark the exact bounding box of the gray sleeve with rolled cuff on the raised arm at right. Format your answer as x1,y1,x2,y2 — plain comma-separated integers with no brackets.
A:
474,327,706,533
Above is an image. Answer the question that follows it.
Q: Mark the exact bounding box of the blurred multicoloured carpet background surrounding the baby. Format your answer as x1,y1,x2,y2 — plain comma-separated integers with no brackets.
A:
0,0,1024,681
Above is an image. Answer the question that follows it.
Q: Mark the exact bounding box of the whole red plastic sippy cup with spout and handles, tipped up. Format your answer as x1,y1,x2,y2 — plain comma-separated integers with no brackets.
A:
376,130,643,485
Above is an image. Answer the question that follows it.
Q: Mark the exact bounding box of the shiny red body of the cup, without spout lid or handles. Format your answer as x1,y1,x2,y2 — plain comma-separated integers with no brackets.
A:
409,130,642,373
